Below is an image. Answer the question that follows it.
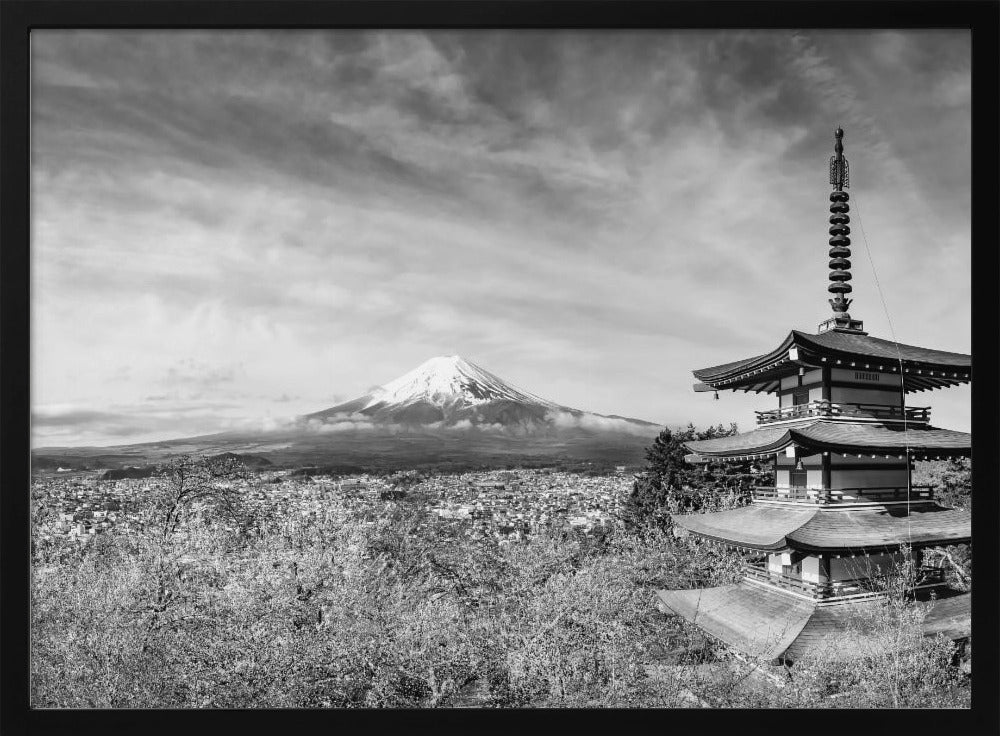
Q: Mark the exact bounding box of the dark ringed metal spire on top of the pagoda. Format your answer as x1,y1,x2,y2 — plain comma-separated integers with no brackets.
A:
819,128,863,332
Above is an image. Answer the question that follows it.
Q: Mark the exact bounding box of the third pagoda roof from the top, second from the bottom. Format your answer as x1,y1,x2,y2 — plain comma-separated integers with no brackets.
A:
673,501,972,551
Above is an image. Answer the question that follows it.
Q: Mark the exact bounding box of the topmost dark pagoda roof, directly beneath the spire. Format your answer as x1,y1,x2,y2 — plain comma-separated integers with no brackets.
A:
693,330,972,393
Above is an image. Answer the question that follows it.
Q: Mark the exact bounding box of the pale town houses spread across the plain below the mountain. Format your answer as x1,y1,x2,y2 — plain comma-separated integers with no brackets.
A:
32,468,632,542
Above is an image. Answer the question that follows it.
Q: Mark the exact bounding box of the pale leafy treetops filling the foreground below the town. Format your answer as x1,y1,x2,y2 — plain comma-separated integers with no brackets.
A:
31,458,968,708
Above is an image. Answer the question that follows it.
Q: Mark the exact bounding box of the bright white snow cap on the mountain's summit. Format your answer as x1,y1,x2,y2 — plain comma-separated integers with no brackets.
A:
365,355,561,409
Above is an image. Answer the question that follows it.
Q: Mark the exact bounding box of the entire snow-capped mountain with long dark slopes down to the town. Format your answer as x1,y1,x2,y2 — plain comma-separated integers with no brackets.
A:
33,355,662,471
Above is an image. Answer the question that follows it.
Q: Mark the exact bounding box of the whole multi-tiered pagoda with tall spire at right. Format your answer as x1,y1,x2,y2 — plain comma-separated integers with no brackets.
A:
658,128,971,663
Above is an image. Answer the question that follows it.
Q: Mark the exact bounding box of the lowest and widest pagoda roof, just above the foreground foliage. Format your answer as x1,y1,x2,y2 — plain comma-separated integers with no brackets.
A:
657,581,970,661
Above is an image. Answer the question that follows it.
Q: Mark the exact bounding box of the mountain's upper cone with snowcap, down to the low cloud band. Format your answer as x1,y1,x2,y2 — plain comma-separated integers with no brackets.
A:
304,355,660,434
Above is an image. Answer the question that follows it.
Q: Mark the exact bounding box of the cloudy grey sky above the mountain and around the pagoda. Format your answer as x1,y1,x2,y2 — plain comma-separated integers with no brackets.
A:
31,31,971,447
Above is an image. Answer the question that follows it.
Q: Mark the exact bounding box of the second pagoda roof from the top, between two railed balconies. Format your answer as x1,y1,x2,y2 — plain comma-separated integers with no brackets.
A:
684,418,972,458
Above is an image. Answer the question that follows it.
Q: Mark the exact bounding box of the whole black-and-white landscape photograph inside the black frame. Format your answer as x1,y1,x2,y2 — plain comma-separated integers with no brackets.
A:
19,28,980,709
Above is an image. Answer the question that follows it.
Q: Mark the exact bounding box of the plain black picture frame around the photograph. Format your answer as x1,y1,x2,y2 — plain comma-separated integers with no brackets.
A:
0,0,1000,734
